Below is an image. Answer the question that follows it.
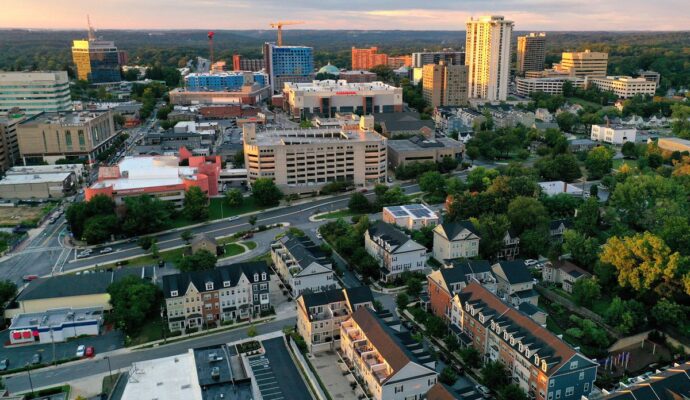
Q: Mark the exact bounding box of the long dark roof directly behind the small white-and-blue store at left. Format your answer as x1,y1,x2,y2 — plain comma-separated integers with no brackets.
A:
17,267,155,301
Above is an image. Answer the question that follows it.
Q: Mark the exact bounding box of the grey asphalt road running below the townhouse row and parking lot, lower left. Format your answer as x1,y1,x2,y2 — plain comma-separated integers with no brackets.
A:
5,317,296,393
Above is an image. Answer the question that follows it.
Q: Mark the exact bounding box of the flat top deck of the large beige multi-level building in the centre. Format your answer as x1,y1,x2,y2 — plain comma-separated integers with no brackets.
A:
250,127,384,146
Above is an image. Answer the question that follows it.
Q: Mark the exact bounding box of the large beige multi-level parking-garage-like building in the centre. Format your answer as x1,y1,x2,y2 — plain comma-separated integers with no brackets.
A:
243,116,387,193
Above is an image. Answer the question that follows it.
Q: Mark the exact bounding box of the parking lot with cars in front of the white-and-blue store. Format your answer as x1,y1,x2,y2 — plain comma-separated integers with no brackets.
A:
0,331,124,370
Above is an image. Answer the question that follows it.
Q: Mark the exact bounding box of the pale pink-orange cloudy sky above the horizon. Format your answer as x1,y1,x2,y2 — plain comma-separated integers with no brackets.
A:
0,0,690,31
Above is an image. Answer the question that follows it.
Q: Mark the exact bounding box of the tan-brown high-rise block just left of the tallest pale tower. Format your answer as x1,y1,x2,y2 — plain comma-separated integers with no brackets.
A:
422,61,467,107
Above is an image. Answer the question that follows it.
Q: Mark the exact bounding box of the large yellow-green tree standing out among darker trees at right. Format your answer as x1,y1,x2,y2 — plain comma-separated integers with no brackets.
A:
601,232,690,296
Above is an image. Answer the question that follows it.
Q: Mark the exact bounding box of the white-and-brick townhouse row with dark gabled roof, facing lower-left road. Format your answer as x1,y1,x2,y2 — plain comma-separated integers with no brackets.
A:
162,261,271,332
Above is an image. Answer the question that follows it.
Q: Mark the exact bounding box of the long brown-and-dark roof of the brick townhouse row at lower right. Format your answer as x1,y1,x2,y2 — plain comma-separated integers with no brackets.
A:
458,282,597,376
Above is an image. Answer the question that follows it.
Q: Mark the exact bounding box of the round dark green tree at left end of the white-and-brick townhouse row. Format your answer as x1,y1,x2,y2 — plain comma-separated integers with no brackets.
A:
108,275,161,335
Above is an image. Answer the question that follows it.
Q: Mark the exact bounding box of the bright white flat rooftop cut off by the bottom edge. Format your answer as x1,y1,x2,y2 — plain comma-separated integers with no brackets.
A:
122,353,202,400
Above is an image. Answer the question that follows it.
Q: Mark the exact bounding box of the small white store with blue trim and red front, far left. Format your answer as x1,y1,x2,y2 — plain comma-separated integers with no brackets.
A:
9,307,103,344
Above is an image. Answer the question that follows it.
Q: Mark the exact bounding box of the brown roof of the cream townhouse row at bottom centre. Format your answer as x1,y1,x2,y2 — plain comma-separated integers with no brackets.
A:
352,307,430,378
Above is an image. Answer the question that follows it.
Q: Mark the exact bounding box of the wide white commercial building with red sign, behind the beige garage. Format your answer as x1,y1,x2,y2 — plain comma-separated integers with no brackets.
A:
283,80,403,117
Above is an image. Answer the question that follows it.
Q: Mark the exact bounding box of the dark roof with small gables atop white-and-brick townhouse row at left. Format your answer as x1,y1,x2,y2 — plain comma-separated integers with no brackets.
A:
163,261,271,299
